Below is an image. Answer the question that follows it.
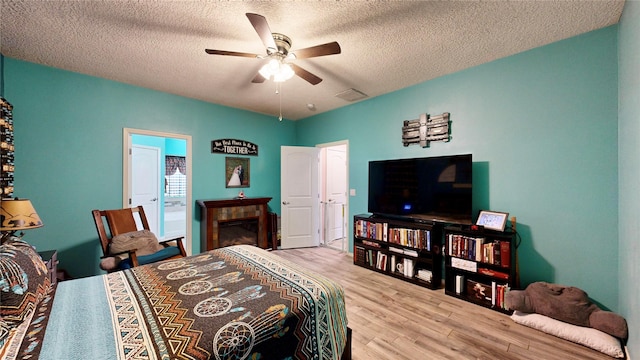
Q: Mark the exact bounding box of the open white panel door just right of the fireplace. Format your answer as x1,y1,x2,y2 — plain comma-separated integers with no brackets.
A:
280,146,320,249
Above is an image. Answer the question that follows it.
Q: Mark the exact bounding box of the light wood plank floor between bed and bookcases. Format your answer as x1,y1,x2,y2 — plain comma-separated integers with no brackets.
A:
275,247,613,360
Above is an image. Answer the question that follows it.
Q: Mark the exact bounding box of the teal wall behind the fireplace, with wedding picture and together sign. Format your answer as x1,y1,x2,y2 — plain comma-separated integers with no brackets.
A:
4,58,295,277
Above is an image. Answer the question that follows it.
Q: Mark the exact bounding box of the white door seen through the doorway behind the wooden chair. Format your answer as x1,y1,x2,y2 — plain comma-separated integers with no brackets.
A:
130,145,160,236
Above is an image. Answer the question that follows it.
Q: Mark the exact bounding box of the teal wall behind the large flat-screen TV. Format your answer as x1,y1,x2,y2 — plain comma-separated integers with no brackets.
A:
296,26,618,309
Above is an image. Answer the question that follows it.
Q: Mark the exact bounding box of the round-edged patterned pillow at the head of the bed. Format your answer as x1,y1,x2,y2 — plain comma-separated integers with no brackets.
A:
0,240,51,331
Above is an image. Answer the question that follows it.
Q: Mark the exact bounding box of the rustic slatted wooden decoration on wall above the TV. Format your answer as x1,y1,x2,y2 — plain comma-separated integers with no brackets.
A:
402,113,451,147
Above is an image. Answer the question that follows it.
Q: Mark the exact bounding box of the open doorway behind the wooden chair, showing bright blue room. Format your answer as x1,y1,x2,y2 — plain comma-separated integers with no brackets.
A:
122,128,192,254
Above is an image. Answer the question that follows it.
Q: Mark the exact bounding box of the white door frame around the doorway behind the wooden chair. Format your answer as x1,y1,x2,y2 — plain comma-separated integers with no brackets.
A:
122,128,193,255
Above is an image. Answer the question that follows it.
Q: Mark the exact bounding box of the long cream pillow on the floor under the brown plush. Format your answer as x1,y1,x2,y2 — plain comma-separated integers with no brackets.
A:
511,310,624,359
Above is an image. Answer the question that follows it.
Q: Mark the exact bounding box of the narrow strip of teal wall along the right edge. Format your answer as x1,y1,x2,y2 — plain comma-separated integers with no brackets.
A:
618,1,640,359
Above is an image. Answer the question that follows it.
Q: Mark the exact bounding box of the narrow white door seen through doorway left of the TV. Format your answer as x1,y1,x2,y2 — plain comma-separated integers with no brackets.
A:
325,145,347,241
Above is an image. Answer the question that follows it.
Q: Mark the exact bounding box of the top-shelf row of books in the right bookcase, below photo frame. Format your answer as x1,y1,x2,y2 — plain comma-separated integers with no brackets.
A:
446,234,511,267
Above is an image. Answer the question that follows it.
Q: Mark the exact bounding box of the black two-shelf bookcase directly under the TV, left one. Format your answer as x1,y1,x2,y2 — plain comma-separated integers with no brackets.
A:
353,214,442,289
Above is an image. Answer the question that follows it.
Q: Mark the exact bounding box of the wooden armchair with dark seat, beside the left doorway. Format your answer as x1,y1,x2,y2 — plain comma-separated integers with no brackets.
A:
91,206,187,270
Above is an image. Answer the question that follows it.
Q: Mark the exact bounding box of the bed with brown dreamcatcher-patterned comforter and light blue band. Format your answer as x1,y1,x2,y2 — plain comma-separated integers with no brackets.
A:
0,242,351,360
